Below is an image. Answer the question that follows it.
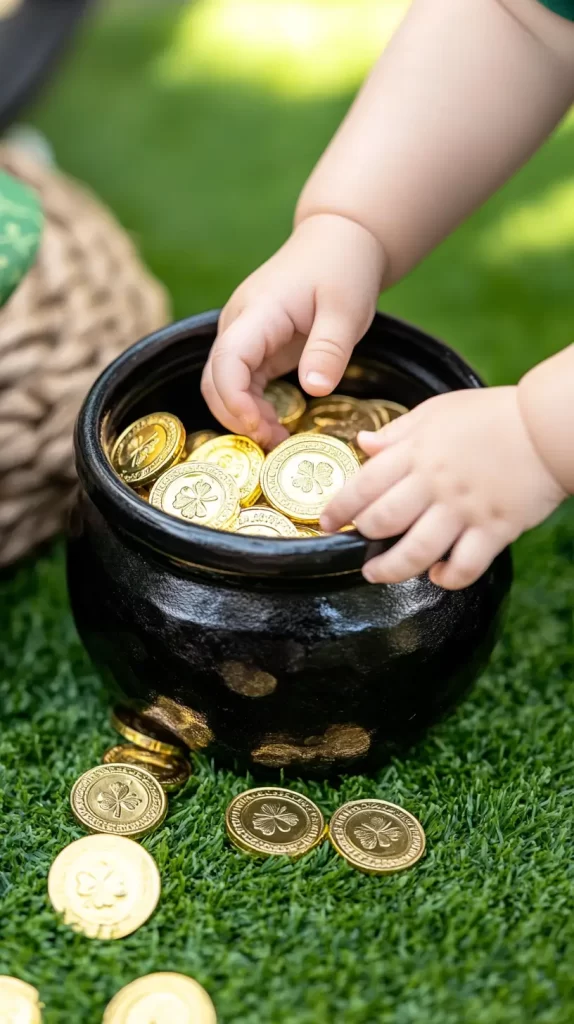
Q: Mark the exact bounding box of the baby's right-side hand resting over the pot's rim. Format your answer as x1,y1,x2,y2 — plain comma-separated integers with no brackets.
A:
321,387,567,590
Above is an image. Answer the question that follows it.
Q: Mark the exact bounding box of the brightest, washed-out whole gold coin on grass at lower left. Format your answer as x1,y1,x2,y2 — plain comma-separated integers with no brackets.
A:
48,836,162,939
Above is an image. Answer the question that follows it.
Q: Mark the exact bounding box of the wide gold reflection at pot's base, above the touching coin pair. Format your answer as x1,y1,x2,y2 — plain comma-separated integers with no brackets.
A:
252,725,370,768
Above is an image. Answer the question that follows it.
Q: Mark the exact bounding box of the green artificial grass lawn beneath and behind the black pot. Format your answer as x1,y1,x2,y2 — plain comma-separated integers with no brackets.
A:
0,0,574,1024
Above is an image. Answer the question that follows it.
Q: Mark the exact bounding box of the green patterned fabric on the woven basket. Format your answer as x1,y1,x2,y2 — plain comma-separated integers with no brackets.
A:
0,171,43,306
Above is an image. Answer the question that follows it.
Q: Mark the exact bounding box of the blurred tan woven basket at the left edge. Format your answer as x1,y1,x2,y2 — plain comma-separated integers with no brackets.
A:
0,145,170,565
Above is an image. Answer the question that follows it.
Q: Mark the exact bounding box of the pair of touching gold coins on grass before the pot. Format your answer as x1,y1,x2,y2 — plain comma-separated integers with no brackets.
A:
225,786,426,874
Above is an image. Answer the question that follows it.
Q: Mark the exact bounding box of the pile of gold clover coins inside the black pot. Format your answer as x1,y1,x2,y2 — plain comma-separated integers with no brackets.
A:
106,380,407,538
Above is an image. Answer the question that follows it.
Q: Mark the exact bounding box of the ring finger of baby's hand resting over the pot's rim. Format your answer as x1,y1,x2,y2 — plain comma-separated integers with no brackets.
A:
363,505,461,583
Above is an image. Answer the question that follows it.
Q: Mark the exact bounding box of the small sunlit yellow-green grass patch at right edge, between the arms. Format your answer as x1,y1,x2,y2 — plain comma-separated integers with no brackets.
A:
480,178,574,264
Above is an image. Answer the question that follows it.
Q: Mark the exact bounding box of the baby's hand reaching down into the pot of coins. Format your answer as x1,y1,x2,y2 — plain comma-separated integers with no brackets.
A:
202,214,384,446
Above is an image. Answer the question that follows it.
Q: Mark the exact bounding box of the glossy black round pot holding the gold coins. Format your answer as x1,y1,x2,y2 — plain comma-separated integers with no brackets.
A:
68,312,512,774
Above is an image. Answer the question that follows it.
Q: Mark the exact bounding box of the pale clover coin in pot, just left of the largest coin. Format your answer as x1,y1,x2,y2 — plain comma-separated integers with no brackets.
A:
149,462,239,529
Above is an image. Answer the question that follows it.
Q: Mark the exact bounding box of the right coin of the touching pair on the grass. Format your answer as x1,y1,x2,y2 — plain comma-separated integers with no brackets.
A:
328,800,426,874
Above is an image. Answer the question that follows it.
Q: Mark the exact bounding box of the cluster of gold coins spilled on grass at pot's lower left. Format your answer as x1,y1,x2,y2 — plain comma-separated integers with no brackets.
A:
48,707,191,939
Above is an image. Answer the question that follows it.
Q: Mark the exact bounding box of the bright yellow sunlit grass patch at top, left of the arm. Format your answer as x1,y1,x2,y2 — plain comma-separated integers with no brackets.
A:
156,0,408,96
